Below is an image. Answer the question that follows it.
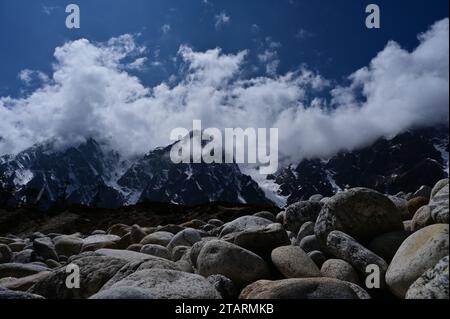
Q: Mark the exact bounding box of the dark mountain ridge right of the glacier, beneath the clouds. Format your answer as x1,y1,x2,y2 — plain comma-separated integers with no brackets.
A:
269,127,449,204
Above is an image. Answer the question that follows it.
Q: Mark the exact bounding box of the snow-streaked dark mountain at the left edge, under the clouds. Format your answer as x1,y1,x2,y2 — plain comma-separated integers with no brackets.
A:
0,139,123,210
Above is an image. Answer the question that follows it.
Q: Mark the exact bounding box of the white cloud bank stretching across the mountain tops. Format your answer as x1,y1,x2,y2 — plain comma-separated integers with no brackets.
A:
0,19,449,168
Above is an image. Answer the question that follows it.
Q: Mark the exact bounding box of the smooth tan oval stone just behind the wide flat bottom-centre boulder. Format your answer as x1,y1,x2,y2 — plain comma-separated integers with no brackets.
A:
272,246,321,278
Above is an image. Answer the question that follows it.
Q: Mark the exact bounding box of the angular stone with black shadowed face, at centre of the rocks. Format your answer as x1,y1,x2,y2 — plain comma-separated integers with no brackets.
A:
222,224,291,259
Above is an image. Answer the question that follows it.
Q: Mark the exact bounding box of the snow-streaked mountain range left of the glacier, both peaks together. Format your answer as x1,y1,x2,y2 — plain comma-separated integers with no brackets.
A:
0,135,270,210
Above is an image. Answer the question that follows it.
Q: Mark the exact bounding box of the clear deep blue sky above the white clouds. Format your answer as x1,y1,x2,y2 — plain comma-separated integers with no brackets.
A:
0,0,448,96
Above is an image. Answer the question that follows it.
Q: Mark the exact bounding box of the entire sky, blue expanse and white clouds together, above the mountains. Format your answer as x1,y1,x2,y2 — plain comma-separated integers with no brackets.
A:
0,0,449,162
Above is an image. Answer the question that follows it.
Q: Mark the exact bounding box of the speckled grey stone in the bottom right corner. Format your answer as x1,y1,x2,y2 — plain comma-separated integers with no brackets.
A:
406,256,449,300
